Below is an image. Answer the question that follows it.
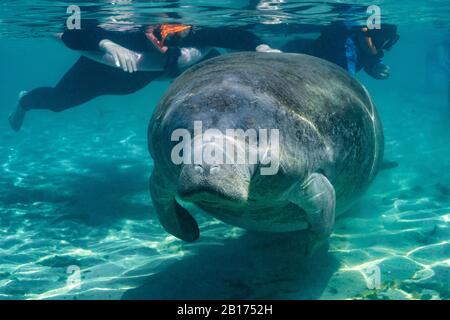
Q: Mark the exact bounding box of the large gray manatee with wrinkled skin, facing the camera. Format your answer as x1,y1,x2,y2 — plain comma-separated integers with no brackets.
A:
148,53,384,241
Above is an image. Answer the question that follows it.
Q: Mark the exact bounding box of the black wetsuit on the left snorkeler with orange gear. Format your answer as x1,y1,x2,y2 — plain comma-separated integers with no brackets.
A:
20,27,261,112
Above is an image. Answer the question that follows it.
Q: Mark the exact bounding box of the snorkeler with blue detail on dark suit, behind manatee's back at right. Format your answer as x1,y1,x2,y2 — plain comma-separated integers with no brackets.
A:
282,22,399,79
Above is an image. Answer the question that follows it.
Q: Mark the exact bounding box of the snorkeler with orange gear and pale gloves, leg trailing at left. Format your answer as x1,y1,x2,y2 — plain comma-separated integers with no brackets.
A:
9,24,270,131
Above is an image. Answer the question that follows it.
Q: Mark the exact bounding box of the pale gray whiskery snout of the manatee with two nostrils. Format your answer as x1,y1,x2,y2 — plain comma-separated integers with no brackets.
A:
178,164,250,203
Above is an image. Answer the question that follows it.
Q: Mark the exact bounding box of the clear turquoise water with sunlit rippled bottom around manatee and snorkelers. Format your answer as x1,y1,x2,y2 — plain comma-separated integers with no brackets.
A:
0,1,450,299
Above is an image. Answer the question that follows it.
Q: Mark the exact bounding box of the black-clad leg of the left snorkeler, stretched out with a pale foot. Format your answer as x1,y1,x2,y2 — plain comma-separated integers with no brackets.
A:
10,57,162,131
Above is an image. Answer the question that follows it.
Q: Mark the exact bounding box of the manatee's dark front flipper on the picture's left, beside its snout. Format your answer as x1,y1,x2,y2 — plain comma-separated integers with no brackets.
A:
150,170,200,242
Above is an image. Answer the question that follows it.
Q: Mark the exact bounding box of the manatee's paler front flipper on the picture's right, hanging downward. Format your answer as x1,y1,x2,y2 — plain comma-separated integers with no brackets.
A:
291,173,336,251
